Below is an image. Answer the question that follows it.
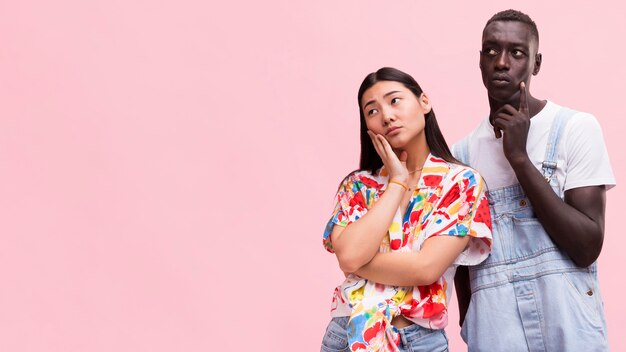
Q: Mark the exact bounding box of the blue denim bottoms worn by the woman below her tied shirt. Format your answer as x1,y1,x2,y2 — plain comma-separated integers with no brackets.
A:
320,317,448,352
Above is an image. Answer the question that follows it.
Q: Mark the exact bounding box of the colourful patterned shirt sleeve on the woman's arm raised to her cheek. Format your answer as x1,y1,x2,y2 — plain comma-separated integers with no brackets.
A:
323,173,376,253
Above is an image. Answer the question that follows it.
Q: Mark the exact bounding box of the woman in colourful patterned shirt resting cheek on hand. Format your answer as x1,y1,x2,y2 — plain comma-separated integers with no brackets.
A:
322,68,491,351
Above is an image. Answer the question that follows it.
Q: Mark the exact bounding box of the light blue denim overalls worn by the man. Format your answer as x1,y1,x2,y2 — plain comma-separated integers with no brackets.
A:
455,108,609,352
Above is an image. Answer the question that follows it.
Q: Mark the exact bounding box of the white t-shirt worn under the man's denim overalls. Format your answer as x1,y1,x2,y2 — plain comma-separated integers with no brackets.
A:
452,101,615,196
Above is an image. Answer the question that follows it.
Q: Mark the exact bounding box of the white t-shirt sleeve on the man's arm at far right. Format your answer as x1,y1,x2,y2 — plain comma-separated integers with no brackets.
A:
563,113,615,190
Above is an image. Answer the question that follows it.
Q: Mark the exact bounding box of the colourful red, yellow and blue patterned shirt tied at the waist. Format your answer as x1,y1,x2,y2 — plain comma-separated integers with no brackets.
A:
323,154,491,351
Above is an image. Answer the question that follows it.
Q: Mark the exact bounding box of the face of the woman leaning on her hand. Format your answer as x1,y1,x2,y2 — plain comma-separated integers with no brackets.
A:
361,81,431,149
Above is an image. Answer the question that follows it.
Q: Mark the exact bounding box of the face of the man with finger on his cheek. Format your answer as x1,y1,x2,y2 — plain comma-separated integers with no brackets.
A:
480,21,541,104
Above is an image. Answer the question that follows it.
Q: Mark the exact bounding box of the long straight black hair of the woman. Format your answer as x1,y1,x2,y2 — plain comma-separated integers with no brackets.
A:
358,67,462,173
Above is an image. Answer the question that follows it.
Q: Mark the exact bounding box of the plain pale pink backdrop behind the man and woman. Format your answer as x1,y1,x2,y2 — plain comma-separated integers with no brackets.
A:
0,0,626,352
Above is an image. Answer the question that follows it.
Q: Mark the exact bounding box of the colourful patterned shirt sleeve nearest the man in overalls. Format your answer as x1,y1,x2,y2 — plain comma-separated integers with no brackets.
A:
426,168,492,265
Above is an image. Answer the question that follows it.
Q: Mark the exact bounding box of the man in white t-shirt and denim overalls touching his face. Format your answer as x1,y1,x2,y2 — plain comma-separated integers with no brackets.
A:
453,10,615,352
